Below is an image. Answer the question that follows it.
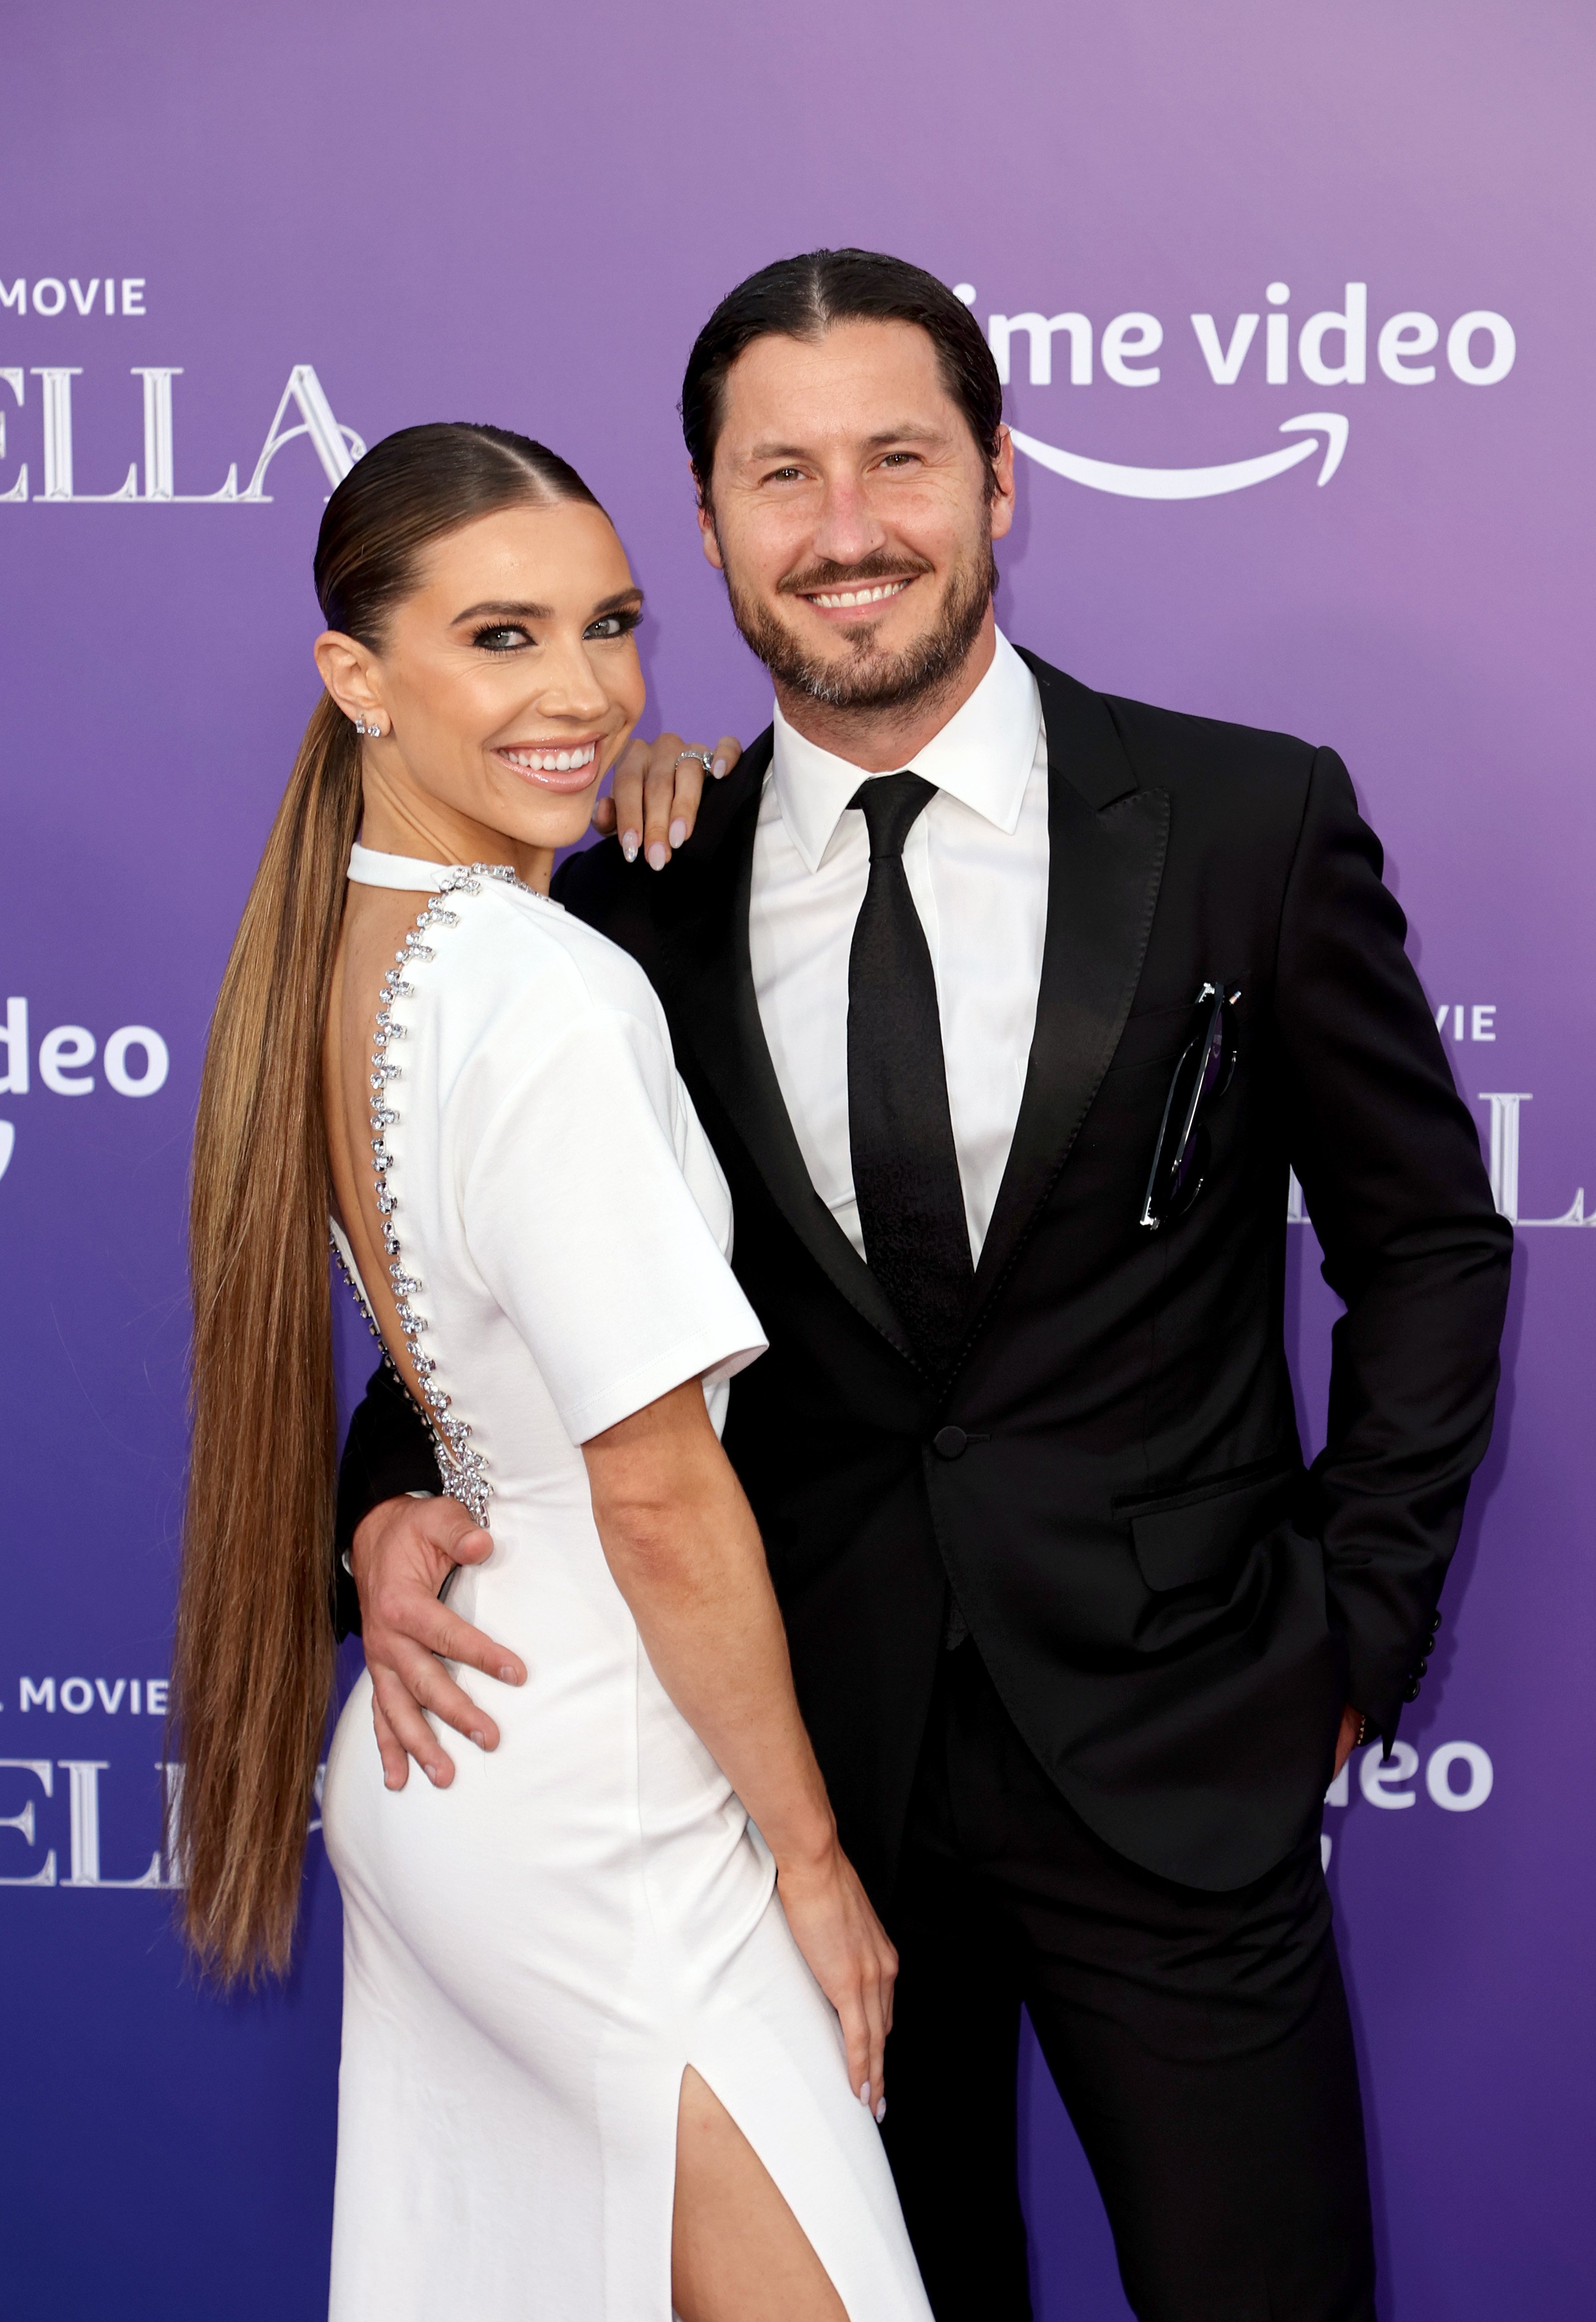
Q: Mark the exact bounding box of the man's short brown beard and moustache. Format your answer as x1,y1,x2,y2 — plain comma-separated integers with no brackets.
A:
725,541,997,711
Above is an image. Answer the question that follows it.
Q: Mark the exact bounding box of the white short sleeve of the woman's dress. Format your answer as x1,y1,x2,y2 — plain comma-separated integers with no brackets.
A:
465,1008,764,1444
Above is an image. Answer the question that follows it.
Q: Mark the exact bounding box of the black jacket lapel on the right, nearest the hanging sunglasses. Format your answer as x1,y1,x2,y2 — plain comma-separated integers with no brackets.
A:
971,652,1169,1328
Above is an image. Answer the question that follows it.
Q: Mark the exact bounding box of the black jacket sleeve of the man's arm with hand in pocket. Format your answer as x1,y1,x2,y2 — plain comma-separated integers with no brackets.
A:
1276,750,1512,1744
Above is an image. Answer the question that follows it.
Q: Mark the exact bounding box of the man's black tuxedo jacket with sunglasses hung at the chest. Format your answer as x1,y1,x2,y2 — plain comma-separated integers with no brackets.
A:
341,655,1510,1900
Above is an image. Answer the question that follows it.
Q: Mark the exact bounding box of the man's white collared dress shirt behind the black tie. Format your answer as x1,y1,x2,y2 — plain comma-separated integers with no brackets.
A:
748,632,1048,1261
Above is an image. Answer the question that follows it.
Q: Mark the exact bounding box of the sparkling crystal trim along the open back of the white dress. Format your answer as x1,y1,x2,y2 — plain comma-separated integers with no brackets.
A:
332,864,532,1528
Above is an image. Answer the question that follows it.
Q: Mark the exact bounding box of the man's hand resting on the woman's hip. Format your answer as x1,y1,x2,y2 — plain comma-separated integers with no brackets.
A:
348,1498,528,1790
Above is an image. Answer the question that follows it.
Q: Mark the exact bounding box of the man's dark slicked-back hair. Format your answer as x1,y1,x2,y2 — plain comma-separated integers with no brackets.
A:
681,251,1004,504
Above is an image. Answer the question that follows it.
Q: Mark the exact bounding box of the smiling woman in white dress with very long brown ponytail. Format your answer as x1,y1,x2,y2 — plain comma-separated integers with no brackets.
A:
177,427,927,2322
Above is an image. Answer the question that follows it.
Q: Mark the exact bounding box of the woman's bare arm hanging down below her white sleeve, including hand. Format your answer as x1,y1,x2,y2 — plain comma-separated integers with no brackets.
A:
583,1379,897,2117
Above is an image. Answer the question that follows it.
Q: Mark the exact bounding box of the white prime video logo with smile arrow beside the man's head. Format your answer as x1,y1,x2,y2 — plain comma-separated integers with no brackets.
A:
953,281,1517,499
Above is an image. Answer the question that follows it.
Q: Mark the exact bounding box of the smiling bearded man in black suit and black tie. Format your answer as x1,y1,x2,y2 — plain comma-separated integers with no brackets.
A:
344,251,1510,2322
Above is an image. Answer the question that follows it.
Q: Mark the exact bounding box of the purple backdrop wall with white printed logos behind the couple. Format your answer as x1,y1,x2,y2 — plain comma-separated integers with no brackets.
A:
0,0,1596,2322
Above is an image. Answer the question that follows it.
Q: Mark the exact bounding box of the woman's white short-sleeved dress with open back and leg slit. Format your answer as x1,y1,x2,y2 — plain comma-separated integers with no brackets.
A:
323,847,929,2322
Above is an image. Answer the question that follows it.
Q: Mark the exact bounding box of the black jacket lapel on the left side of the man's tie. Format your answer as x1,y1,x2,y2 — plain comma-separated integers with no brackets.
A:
657,734,915,1361
